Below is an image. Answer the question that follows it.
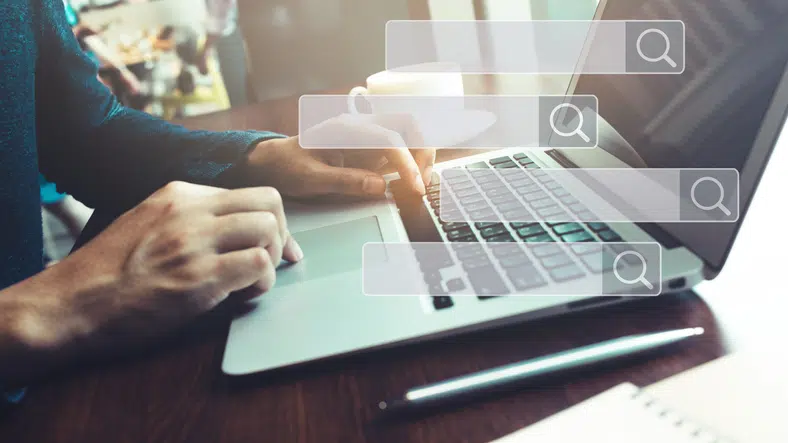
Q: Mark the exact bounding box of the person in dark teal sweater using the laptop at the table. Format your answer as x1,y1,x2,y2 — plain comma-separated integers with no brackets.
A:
0,0,435,399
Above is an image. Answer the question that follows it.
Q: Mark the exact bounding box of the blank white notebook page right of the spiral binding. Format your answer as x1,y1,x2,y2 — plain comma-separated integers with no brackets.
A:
644,349,788,443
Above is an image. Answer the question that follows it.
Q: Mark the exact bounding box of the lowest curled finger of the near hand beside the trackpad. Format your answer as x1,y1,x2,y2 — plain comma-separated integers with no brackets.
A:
217,248,276,296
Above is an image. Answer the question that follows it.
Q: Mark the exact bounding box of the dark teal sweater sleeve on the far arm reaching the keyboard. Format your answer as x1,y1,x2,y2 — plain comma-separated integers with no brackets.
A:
35,0,282,209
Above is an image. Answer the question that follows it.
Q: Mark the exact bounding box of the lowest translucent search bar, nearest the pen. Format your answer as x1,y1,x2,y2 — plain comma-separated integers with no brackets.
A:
362,242,662,298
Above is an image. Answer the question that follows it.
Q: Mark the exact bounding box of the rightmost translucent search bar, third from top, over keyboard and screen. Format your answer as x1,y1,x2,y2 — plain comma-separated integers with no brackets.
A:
438,166,740,223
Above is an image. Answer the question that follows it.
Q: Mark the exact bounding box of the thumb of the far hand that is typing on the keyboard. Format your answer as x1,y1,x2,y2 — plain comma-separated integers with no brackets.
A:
312,163,386,197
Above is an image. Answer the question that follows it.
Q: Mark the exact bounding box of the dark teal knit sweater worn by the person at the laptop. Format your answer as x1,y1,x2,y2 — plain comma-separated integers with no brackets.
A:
0,0,277,289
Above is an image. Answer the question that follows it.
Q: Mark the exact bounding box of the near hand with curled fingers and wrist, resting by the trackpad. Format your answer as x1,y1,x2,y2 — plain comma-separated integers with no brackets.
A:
22,182,303,348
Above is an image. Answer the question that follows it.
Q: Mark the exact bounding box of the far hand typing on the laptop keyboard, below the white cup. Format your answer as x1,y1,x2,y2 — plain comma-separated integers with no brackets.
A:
246,116,435,198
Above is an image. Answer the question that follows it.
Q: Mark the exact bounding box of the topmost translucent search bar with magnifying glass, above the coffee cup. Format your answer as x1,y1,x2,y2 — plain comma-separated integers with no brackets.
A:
386,20,686,74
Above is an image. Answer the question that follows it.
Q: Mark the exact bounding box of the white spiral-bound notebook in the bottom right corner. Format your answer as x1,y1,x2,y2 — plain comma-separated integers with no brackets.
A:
493,354,788,443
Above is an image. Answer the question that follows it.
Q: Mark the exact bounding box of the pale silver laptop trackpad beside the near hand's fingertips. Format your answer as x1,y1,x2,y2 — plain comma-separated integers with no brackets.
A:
276,216,383,287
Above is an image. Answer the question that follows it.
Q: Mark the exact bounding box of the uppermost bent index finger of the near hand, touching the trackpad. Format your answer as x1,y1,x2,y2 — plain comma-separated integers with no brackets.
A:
209,187,288,248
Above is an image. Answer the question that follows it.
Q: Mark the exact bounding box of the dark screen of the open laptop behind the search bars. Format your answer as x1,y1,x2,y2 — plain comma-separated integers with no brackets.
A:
574,0,788,266
